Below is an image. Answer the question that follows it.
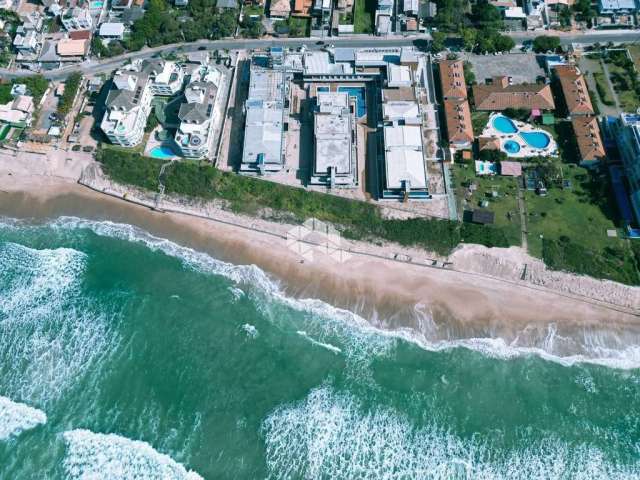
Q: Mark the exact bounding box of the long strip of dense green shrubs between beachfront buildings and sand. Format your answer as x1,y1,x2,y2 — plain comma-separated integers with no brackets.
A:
97,148,509,254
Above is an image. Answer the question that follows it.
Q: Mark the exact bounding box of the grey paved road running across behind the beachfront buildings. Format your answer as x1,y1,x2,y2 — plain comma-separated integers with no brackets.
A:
0,30,640,80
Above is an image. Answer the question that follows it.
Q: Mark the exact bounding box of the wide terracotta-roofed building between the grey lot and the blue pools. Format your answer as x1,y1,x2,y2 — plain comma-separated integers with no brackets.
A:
473,77,555,111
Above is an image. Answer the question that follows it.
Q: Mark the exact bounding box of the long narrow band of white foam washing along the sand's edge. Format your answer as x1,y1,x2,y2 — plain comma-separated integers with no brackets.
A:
46,217,640,370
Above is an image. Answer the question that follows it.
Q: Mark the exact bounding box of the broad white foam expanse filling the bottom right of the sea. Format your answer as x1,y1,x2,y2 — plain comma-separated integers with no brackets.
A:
263,386,640,480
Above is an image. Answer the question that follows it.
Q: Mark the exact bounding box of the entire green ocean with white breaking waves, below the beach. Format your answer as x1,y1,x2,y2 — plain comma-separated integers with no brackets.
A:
0,218,640,480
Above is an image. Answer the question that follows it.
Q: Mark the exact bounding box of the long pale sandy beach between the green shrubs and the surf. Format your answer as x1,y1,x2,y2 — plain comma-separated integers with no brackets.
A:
0,150,640,352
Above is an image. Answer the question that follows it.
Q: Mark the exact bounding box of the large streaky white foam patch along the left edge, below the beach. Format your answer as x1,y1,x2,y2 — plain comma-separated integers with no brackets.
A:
0,242,119,405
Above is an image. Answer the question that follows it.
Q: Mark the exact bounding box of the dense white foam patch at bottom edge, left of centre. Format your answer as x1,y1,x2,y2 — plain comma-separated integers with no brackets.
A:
63,430,202,480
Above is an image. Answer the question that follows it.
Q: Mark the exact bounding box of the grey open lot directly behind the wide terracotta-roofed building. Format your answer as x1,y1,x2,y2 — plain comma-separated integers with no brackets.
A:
467,53,544,83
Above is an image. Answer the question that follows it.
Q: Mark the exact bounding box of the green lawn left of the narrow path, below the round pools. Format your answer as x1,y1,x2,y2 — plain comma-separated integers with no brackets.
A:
452,163,522,245
